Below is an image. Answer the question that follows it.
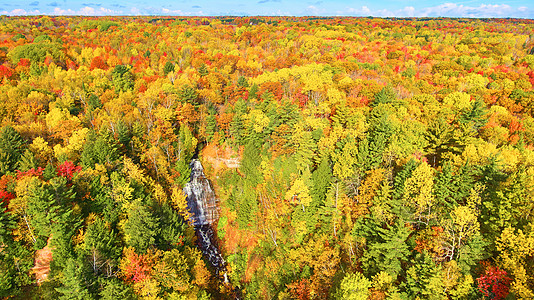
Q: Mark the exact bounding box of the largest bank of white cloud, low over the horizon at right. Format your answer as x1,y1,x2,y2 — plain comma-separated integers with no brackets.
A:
344,3,534,18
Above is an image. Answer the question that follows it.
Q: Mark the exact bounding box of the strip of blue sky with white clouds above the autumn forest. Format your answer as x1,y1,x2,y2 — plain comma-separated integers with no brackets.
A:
0,0,534,19
